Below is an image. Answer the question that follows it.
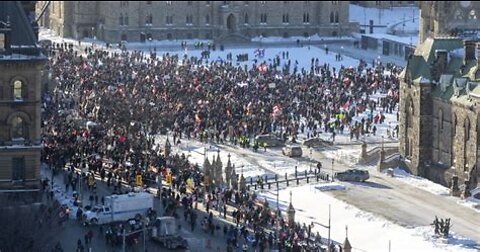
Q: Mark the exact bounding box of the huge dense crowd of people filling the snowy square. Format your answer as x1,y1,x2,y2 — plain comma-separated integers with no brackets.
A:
42,40,401,251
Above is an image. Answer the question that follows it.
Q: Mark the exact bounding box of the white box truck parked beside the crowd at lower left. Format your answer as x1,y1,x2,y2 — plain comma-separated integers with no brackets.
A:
84,192,153,224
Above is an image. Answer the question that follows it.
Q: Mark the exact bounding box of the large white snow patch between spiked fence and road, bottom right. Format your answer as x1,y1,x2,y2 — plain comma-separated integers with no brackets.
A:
259,184,476,252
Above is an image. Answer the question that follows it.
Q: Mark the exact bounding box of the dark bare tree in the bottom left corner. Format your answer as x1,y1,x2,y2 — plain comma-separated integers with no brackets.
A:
0,194,65,252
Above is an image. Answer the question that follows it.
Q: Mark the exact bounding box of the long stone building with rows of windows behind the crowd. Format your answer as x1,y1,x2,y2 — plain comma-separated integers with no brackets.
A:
37,1,358,43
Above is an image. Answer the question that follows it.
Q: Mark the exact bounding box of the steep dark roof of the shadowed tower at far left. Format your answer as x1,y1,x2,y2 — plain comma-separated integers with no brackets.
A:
0,1,40,56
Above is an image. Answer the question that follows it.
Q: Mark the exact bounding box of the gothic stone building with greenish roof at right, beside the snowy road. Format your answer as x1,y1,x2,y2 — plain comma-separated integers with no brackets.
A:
399,38,480,189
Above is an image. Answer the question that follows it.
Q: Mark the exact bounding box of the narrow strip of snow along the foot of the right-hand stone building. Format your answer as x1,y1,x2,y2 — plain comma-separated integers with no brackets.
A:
393,168,450,196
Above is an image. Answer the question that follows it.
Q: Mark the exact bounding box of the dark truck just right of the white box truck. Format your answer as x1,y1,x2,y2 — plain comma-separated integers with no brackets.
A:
152,216,188,249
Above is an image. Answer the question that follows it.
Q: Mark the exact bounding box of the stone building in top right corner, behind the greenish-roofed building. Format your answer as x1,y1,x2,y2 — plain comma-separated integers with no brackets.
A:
419,1,480,43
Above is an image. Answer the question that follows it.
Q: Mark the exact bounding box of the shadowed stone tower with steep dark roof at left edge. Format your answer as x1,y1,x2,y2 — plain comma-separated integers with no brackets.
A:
0,1,47,191
